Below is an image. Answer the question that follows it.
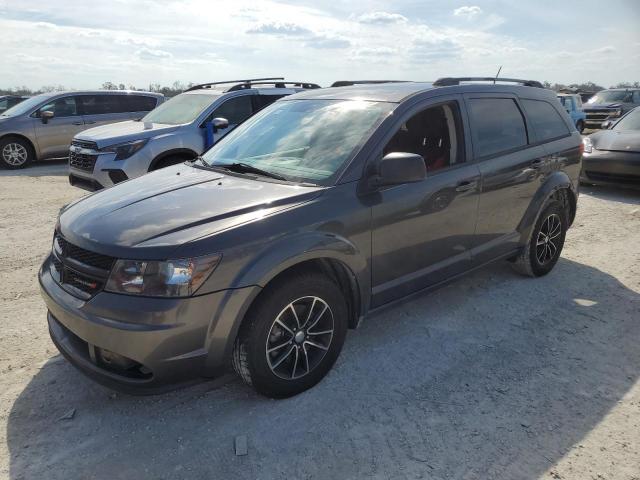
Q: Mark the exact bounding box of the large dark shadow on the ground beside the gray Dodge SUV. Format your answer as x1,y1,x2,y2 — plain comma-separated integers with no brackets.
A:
7,259,640,479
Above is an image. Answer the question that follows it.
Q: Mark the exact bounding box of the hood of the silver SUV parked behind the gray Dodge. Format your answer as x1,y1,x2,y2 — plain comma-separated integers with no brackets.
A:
75,120,180,148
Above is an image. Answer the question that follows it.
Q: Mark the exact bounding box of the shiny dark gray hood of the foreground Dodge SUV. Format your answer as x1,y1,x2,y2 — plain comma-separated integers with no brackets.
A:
58,164,325,259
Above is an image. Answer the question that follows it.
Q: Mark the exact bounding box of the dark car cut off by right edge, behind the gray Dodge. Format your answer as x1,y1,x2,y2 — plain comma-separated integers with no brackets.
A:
580,107,640,188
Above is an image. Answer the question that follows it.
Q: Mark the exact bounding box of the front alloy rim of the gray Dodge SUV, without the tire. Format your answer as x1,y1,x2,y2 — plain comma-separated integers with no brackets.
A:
266,296,334,380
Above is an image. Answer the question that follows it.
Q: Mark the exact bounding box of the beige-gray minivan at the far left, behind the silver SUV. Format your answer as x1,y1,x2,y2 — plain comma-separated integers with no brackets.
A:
0,90,164,169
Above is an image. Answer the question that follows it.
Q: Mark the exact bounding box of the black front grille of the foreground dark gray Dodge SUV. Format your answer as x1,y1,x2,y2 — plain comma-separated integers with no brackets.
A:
51,233,115,297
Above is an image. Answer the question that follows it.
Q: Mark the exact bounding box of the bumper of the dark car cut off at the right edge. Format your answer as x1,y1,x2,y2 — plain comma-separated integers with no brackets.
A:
580,149,640,188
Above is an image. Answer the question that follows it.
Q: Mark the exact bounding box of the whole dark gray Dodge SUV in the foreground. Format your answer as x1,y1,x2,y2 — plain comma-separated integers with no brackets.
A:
39,78,582,397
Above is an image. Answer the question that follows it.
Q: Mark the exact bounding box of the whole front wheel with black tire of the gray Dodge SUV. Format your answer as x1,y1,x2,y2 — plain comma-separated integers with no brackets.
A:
232,272,347,398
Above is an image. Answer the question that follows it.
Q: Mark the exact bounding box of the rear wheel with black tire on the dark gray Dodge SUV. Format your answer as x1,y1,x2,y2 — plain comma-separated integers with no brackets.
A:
512,200,568,277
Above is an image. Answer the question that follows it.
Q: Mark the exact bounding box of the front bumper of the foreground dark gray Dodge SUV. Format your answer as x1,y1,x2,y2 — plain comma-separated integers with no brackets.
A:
39,255,259,394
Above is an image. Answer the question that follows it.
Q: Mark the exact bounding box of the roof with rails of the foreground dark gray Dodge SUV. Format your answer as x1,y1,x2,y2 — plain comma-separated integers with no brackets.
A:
285,80,556,103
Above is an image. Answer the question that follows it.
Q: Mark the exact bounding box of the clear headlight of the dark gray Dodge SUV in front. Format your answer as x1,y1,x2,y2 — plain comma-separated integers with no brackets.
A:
105,254,222,297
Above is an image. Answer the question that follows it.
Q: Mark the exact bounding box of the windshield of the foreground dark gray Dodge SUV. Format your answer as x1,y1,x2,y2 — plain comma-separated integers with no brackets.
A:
204,100,392,185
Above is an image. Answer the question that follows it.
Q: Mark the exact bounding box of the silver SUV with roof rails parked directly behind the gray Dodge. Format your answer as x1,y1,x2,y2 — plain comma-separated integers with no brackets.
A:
69,78,320,191
